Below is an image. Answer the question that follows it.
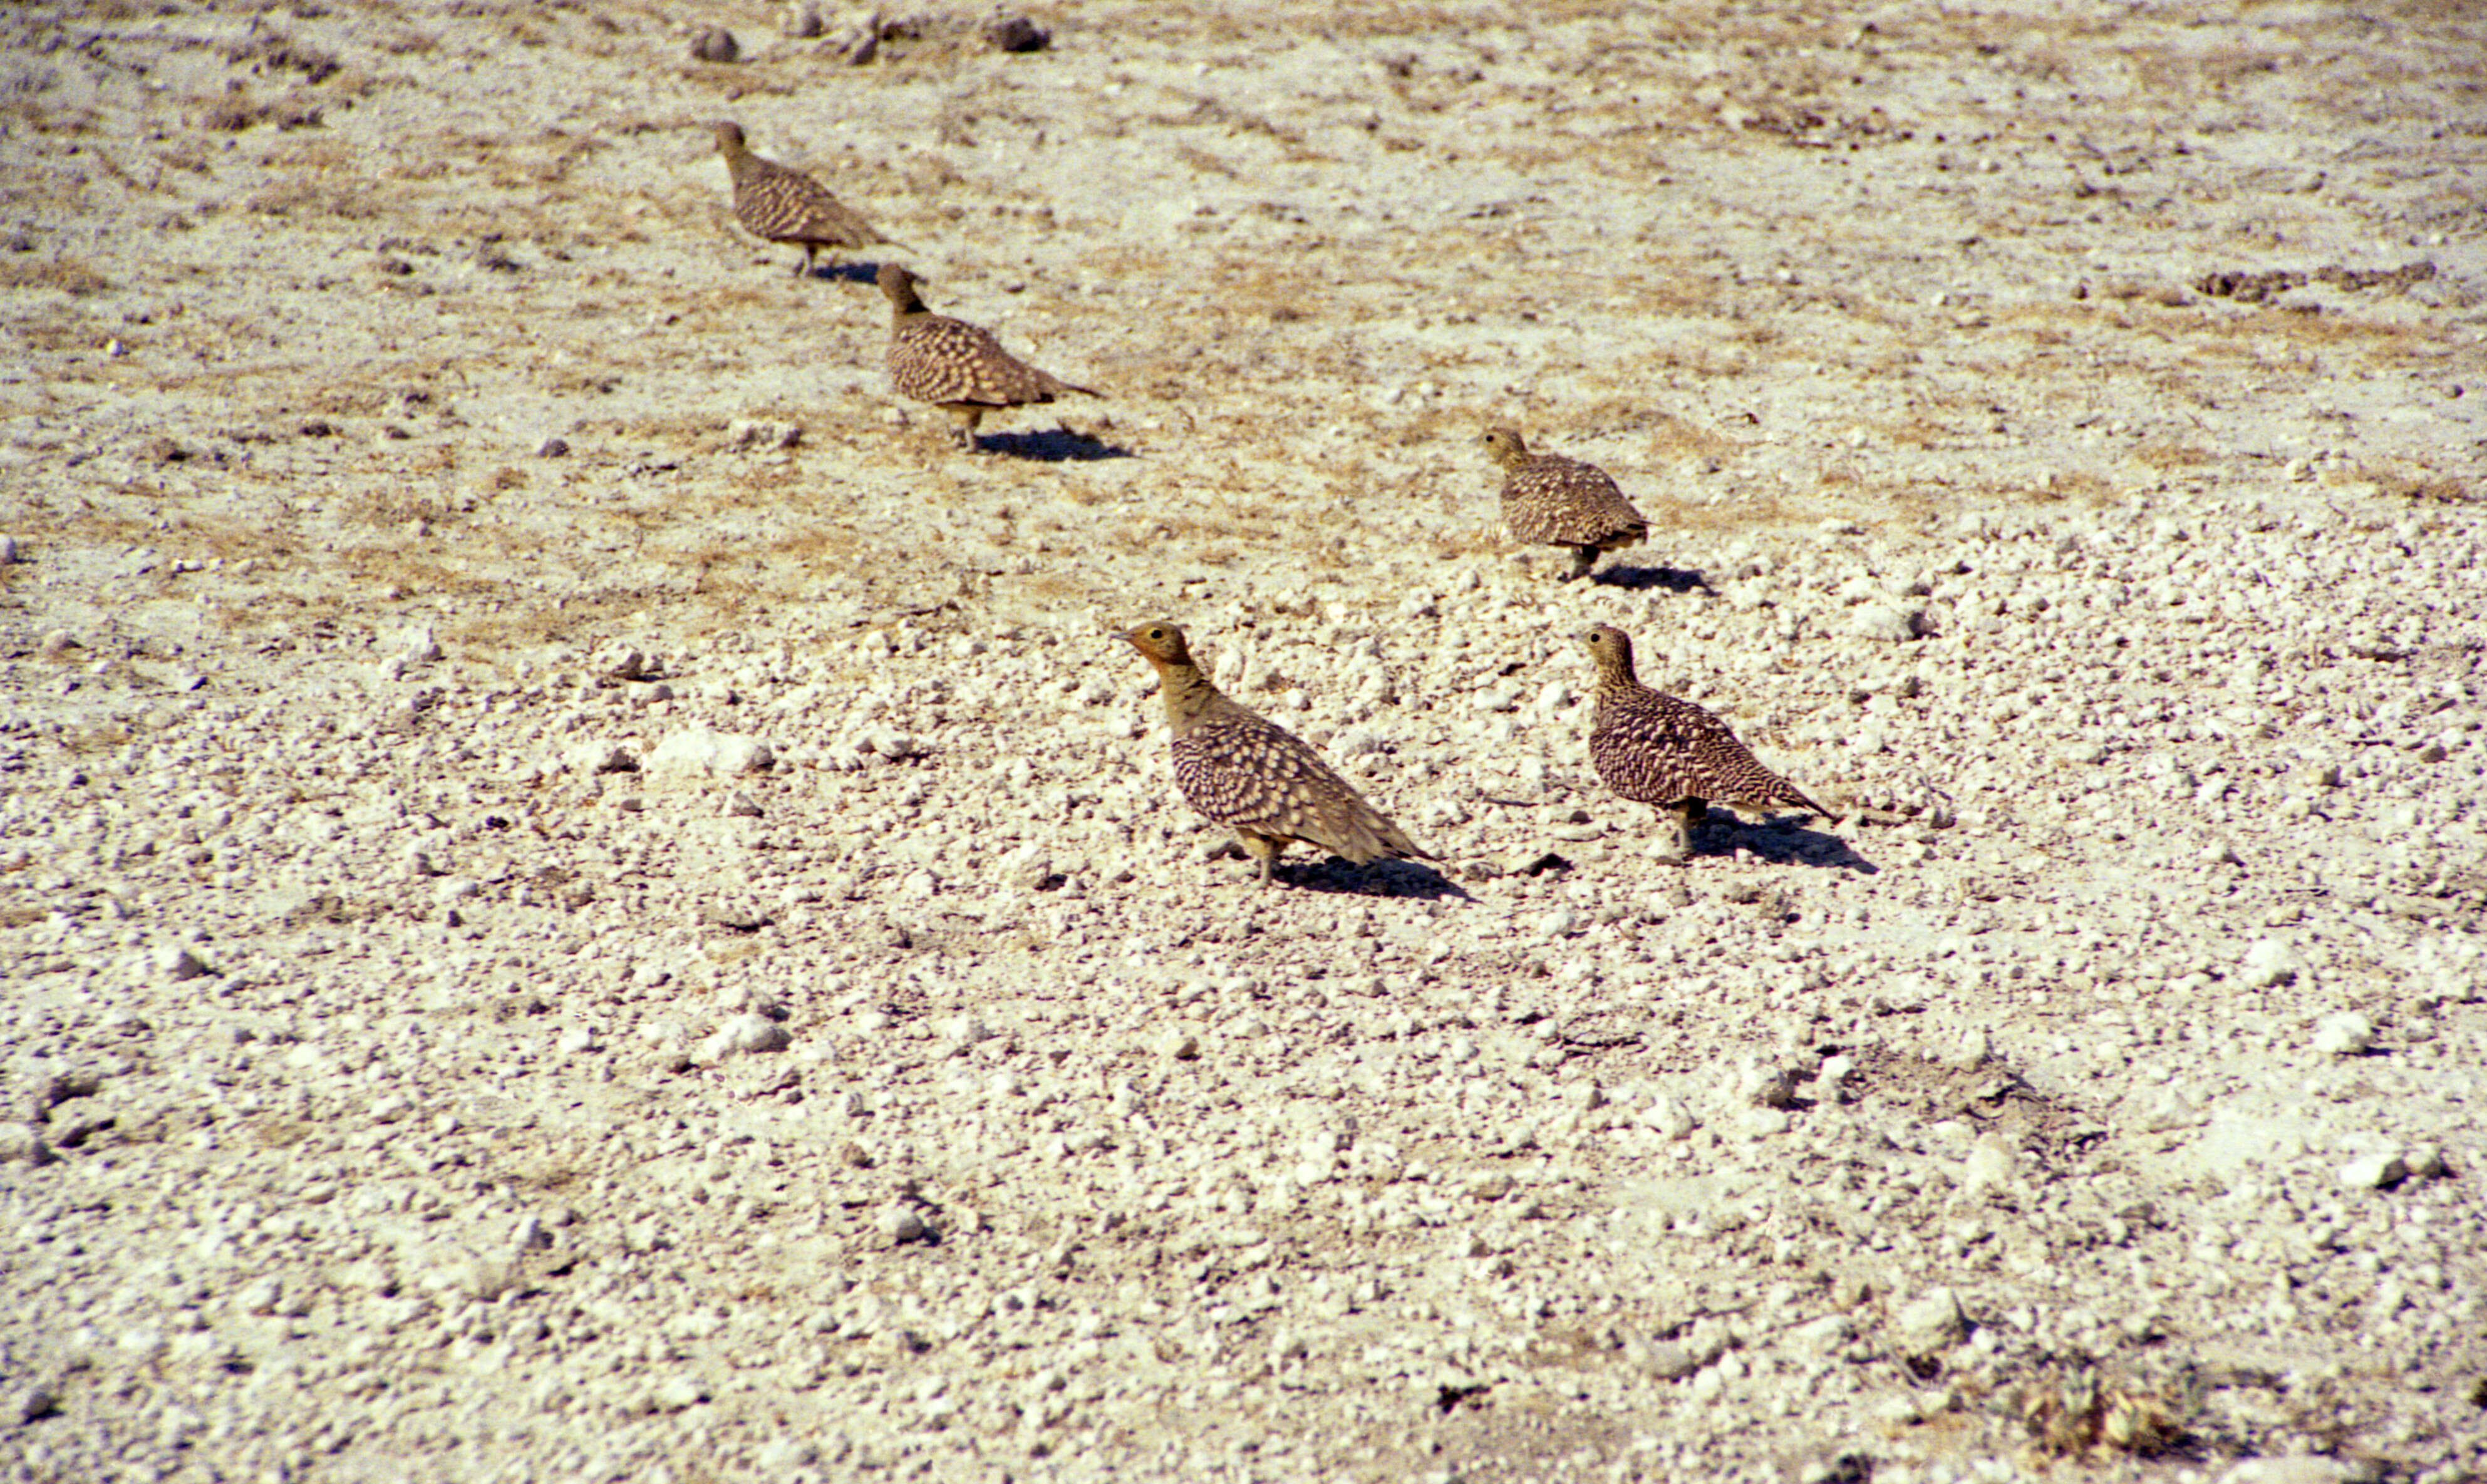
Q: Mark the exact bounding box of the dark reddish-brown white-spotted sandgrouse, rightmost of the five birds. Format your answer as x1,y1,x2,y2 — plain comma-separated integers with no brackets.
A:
1580,624,1831,863
